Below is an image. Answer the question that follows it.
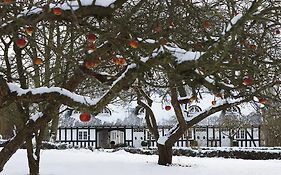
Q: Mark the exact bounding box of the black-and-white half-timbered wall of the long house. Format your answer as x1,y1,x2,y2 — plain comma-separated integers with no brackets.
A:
57,126,261,148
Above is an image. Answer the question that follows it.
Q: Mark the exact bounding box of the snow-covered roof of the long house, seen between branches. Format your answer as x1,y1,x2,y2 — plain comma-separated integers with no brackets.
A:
63,93,256,126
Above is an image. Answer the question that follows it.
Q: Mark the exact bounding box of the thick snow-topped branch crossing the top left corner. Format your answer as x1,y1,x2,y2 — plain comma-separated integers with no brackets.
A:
0,0,122,34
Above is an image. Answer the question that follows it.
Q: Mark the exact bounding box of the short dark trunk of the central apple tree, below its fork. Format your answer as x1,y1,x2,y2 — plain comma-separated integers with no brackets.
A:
157,144,173,166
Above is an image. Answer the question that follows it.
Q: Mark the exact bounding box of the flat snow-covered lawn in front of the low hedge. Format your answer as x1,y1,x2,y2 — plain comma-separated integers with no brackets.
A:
0,149,281,175
